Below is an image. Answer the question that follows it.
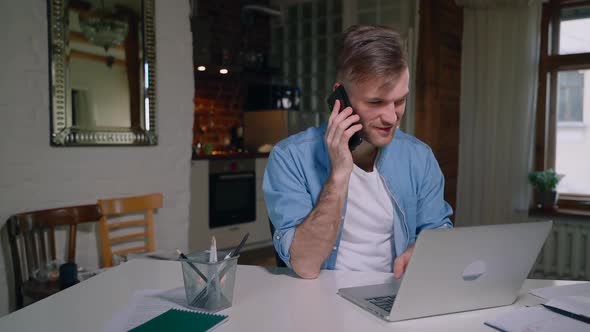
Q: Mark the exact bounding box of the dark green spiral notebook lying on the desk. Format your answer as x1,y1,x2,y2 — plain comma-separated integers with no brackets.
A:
129,309,228,332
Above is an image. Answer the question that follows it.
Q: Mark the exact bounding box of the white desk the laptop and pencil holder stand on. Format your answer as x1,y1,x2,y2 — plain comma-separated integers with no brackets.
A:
0,259,575,332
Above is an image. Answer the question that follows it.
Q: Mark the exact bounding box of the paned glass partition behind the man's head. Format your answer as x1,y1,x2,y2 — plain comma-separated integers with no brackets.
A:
271,0,417,134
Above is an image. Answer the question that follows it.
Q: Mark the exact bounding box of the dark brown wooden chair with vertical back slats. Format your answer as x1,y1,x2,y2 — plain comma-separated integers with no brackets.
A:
6,204,100,309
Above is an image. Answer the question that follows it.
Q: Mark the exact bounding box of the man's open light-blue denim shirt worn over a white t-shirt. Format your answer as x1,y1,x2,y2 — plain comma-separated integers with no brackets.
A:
262,125,453,269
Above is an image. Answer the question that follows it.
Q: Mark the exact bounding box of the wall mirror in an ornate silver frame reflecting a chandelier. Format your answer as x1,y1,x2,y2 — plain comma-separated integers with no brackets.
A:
48,0,157,146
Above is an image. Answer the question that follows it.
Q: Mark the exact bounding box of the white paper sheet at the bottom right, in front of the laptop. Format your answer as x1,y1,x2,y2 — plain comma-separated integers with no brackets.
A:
485,306,588,332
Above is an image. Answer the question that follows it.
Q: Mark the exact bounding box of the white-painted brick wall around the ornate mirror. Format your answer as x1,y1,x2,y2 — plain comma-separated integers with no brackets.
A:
0,0,194,315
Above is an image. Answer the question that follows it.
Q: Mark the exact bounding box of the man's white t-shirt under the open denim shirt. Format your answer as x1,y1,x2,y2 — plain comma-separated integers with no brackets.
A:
335,165,398,272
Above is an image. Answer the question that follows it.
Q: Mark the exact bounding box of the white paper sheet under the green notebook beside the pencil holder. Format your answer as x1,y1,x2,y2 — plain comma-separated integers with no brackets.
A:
102,287,198,332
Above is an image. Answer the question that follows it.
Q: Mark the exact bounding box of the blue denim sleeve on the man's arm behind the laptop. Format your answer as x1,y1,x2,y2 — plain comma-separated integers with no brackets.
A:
414,149,453,236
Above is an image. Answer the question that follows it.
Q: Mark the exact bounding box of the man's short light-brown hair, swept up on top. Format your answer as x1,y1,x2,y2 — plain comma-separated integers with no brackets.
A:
336,25,408,83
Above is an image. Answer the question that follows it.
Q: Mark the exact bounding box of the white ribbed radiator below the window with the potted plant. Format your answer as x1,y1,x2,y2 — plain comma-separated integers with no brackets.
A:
530,220,590,280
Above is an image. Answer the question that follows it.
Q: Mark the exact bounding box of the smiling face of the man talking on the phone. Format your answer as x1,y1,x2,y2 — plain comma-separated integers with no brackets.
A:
344,69,410,147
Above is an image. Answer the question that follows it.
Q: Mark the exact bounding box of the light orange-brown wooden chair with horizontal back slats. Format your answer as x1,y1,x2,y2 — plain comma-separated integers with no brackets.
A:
97,193,162,267
